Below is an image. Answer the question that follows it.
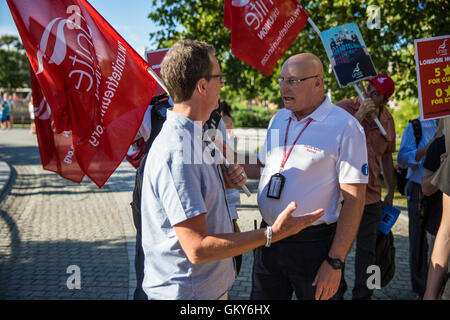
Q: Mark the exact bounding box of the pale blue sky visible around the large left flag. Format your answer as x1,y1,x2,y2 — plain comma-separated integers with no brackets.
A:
0,0,162,57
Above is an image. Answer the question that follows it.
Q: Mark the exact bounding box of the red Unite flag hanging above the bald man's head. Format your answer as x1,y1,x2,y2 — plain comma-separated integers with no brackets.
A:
224,0,308,76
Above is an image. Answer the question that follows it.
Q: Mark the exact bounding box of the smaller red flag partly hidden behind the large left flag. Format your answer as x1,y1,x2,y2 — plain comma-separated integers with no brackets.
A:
30,71,84,183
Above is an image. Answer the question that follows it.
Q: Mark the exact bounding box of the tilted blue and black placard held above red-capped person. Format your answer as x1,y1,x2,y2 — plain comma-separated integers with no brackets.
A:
321,23,377,88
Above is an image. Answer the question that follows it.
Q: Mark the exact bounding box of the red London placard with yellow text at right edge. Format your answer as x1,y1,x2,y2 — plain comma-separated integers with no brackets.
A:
414,35,450,120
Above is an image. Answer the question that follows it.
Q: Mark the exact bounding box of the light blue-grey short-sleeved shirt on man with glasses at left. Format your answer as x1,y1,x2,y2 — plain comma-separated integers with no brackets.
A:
141,111,236,300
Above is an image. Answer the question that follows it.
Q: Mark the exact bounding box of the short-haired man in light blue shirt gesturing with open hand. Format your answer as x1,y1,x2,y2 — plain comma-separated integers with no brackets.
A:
141,40,323,299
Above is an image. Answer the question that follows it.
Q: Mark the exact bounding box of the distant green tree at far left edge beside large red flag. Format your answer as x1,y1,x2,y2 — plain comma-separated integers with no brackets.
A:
0,35,30,92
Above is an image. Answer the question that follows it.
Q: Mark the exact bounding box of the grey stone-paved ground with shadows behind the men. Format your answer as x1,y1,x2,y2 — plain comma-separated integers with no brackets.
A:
0,129,414,300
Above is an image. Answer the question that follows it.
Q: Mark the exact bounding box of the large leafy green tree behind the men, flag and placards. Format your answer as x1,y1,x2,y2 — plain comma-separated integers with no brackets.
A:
149,0,450,103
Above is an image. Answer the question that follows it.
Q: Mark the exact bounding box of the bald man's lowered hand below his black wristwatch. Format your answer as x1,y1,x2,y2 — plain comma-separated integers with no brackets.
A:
312,260,342,300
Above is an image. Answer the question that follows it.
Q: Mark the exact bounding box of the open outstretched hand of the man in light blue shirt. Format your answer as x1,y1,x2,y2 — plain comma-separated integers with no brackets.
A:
272,202,325,242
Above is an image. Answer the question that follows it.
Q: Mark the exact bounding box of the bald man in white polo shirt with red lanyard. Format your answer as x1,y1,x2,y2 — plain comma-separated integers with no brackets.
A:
244,53,368,300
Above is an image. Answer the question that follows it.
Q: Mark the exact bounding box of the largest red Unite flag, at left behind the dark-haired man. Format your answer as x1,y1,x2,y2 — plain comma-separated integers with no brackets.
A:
7,0,156,187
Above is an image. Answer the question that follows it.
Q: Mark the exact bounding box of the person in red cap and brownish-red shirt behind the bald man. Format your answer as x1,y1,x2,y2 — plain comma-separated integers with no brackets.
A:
336,74,395,300
